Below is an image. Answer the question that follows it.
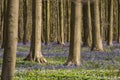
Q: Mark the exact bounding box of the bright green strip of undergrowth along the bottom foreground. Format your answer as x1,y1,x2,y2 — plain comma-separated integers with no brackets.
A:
14,69,120,80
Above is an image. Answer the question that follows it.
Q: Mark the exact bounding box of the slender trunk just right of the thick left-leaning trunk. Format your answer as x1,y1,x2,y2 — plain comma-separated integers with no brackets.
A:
107,0,113,46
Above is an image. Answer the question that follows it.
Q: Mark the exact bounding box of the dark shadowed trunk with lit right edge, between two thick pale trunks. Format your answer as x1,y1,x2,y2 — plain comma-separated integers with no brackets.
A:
83,0,92,47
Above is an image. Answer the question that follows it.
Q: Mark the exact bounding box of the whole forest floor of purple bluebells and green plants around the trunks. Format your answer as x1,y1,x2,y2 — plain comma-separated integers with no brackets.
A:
0,42,120,80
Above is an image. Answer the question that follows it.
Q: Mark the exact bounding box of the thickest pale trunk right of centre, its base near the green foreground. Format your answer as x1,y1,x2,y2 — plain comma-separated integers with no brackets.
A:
65,0,82,66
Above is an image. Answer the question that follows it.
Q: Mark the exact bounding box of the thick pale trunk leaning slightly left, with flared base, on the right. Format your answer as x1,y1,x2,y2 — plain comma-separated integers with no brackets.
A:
91,0,103,51
